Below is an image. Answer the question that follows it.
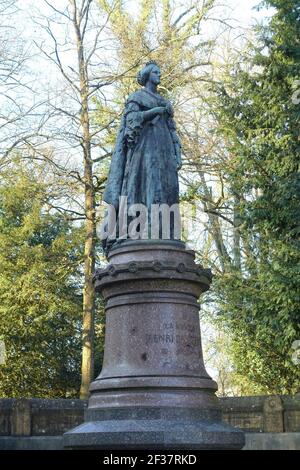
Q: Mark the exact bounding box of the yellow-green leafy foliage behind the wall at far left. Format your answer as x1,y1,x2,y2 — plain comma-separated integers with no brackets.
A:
0,164,83,398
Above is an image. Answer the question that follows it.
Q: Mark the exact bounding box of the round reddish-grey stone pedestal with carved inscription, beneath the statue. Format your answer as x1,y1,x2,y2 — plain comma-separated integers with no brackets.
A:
64,241,244,449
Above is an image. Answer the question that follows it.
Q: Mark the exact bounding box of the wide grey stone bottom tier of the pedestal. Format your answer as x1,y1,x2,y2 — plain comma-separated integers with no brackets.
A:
64,408,244,450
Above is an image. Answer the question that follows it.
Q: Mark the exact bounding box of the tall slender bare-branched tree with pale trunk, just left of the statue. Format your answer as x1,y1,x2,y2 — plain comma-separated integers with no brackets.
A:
30,0,111,398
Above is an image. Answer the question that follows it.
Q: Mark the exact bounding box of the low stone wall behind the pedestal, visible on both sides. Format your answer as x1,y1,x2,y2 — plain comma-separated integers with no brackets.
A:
0,395,300,438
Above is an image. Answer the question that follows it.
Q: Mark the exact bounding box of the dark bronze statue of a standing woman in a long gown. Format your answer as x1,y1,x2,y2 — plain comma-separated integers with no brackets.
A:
103,61,181,252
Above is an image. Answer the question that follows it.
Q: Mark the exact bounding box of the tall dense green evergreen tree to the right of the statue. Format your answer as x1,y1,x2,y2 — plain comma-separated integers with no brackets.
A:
211,0,300,393
